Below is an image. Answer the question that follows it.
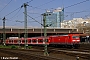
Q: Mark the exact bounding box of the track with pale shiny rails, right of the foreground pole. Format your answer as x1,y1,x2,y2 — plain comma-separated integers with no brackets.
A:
51,49,90,60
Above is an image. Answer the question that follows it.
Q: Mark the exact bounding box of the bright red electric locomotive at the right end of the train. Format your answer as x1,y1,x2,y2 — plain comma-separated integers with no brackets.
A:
49,34,80,48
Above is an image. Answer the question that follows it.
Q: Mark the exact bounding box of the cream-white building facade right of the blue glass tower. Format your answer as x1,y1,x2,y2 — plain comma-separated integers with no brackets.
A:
61,18,90,28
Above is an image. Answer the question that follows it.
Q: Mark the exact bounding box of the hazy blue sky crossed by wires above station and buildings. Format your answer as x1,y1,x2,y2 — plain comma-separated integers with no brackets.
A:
0,0,90,27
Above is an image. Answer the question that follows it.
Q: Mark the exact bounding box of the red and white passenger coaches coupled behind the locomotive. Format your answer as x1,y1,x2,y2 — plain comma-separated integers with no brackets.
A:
6,37,49,45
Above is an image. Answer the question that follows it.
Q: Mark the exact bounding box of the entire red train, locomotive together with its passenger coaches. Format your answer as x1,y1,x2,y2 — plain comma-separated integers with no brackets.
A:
6,34,80,47
